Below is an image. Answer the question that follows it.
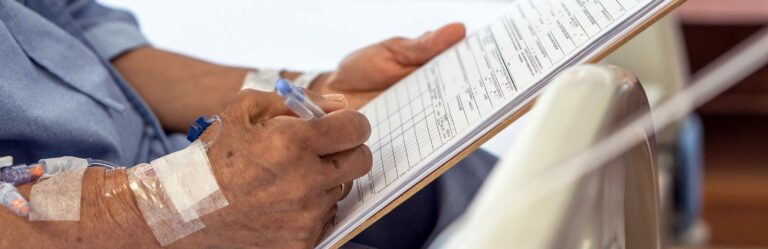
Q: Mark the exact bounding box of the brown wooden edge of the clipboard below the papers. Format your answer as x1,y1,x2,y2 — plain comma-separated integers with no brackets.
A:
331,0,687,249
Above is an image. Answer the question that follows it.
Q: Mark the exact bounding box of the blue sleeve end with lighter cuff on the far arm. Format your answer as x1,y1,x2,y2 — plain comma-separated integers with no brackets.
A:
67,0,148,60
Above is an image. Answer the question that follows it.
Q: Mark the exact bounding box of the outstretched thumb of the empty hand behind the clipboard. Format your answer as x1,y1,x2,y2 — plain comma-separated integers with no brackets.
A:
383,23,466,66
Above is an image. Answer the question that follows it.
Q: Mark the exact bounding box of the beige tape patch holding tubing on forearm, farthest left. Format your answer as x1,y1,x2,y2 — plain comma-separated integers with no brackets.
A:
29,157,88,221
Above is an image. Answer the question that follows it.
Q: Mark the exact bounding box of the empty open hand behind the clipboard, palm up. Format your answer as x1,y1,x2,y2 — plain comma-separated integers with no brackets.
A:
310,24,466,109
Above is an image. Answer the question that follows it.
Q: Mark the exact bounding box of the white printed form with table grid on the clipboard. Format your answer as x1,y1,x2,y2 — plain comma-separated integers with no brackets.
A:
318,0,663,247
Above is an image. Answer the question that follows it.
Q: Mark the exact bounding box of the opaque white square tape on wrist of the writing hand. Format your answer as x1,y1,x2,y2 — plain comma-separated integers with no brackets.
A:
151,140,229,221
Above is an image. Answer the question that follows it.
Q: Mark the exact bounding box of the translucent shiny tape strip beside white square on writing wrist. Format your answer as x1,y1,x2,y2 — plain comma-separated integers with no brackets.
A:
128,164,205,246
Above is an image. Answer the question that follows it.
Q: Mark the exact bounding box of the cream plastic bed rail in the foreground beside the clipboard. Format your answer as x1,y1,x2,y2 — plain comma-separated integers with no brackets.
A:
432,65,662,249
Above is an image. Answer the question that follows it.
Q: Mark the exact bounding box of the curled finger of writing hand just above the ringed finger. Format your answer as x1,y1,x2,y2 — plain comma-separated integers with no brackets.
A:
315,145,373,188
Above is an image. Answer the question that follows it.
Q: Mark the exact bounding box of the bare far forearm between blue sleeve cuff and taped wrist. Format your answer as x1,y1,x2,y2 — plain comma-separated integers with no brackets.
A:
112,47,248,132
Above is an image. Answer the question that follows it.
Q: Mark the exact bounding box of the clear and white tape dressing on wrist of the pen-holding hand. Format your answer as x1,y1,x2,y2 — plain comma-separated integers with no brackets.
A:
128,140,229,246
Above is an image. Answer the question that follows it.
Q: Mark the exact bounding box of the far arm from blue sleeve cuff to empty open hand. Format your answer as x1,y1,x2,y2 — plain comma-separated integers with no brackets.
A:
82,0,465,132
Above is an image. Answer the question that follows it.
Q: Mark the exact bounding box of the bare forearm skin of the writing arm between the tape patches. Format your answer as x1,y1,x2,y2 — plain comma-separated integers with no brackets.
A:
0,168,159,248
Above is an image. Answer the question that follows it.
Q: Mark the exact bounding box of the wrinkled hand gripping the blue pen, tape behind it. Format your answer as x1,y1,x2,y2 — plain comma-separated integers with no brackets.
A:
178,90,372,248
